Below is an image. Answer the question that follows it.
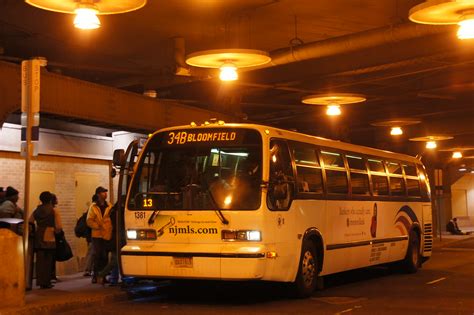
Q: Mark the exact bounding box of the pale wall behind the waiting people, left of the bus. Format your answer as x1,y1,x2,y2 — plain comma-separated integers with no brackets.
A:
0,124,146,275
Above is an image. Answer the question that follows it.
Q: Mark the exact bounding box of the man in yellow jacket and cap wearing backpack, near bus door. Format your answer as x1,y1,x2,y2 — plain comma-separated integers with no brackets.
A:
87,186,112,283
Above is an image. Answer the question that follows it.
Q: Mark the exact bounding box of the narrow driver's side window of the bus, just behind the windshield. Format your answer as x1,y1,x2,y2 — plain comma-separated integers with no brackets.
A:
267,140,294,210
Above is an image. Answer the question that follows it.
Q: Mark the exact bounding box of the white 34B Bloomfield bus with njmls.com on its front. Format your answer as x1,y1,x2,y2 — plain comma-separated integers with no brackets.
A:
114,121,432,296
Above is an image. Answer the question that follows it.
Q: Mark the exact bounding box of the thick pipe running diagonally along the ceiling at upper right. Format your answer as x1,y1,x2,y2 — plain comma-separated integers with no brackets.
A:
259,23,451,69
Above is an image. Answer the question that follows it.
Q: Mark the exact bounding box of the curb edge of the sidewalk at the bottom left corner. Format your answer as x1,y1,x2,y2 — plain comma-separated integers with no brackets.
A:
0,291,128,315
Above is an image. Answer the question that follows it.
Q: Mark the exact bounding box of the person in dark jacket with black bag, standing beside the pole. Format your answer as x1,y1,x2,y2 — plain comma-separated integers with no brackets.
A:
29,191,62,289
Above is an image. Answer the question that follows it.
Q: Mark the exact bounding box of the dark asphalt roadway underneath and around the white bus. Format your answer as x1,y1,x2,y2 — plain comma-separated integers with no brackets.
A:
0,235,474,315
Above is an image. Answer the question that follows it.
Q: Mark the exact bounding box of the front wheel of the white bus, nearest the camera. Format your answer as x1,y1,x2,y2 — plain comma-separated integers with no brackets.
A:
293,240,318,298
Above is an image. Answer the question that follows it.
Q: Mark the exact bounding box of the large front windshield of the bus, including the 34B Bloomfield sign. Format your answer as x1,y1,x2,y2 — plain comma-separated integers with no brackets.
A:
128,128,262,210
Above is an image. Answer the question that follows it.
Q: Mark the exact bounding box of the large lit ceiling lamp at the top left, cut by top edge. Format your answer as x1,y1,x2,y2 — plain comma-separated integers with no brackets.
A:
25,0,147,30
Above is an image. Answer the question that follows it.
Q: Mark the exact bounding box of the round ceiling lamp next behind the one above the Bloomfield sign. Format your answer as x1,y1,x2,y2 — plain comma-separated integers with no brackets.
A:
301,93,366,116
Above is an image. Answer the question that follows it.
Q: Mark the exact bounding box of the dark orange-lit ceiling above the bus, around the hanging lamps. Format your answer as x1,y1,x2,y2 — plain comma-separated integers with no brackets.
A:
0,0,474,167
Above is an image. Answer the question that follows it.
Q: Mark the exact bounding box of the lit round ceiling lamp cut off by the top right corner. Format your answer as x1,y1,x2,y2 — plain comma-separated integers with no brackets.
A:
409,0,474,39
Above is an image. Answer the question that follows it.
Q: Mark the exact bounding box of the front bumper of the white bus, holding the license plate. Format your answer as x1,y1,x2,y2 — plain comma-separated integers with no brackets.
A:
121,243,268,280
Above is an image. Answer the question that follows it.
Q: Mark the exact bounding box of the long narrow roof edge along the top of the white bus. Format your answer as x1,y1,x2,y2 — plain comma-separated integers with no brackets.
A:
156,122,421,164
